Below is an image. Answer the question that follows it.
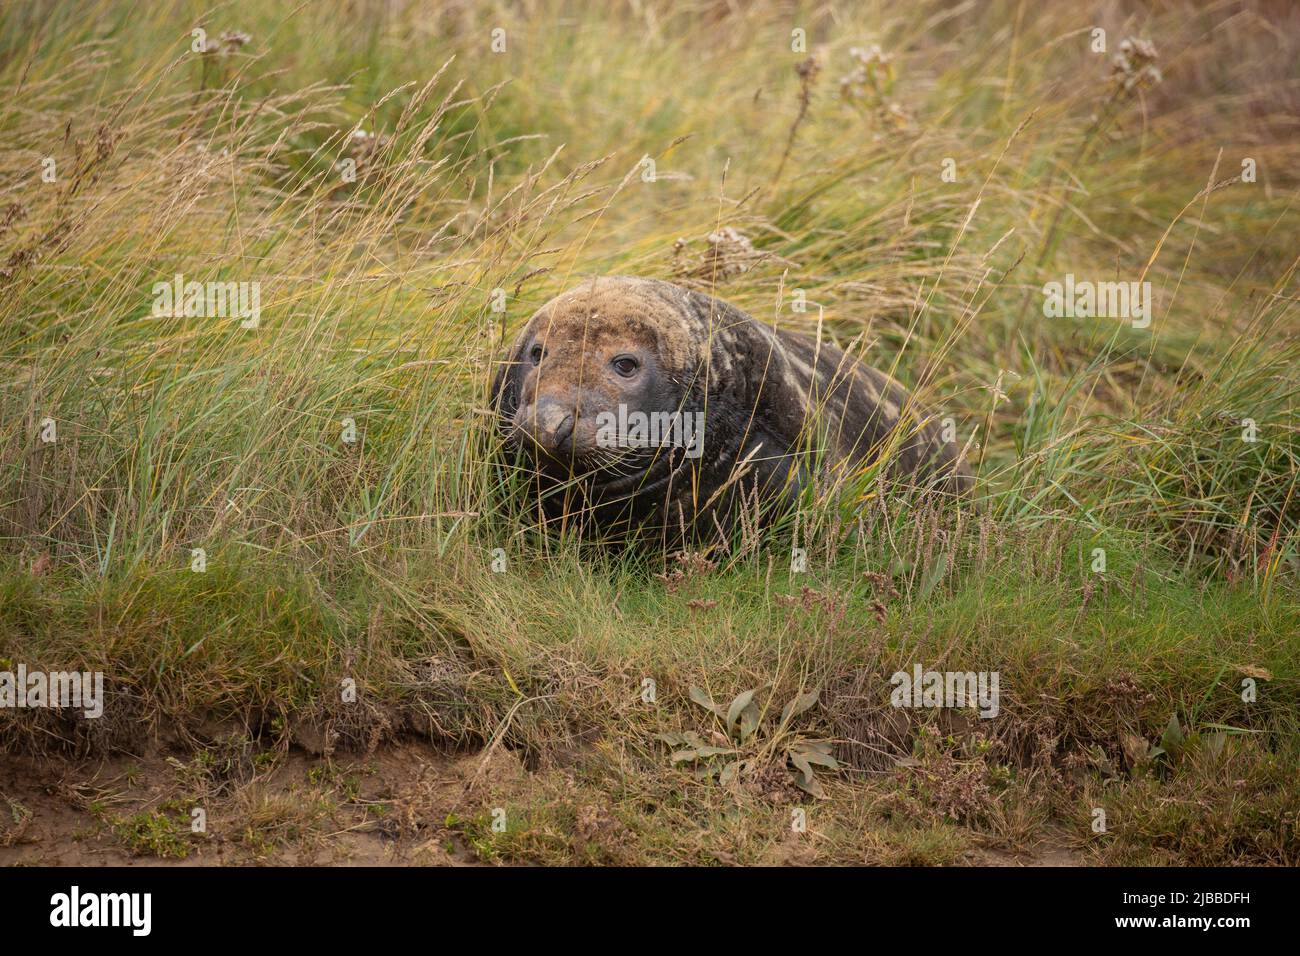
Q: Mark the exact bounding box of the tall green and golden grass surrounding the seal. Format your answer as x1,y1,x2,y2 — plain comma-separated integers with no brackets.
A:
0,0,1300,864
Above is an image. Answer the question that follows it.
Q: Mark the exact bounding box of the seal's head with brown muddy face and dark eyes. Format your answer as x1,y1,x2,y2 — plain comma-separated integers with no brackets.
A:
493,277,707,485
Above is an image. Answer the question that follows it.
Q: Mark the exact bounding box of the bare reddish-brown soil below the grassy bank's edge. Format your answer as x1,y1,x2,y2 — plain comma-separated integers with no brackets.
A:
0,740,1087,866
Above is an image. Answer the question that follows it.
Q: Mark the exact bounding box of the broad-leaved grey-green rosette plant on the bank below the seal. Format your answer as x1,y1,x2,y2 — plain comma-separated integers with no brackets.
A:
657,684,840,797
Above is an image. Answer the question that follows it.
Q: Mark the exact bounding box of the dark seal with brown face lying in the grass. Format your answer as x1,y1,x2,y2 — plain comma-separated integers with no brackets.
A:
491,276,971,540
